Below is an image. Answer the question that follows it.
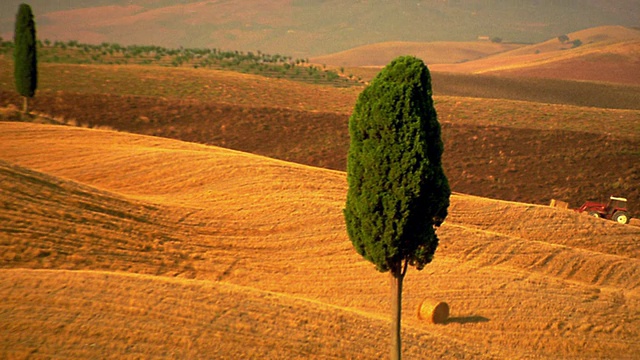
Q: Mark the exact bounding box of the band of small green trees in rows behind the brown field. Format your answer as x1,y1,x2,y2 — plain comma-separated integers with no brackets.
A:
0,37,361,86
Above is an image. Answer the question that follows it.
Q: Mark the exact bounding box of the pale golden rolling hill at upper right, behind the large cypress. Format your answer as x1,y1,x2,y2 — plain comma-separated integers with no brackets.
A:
318,26,640,86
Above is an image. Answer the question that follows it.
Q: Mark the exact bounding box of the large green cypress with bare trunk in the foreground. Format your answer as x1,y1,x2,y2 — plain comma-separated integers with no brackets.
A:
344,56,451,359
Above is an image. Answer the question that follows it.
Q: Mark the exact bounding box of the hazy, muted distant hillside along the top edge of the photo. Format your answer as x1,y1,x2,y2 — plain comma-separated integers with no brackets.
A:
0,0,640,57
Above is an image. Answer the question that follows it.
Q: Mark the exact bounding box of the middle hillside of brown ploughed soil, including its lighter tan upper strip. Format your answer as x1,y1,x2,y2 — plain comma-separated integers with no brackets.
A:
0,48,640,216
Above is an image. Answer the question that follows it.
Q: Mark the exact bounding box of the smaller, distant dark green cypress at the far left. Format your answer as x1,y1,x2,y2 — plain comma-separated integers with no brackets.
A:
13,4,38,114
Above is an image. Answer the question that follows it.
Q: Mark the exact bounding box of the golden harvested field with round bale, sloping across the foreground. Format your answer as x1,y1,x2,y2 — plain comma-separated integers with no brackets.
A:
0,123,640,359
